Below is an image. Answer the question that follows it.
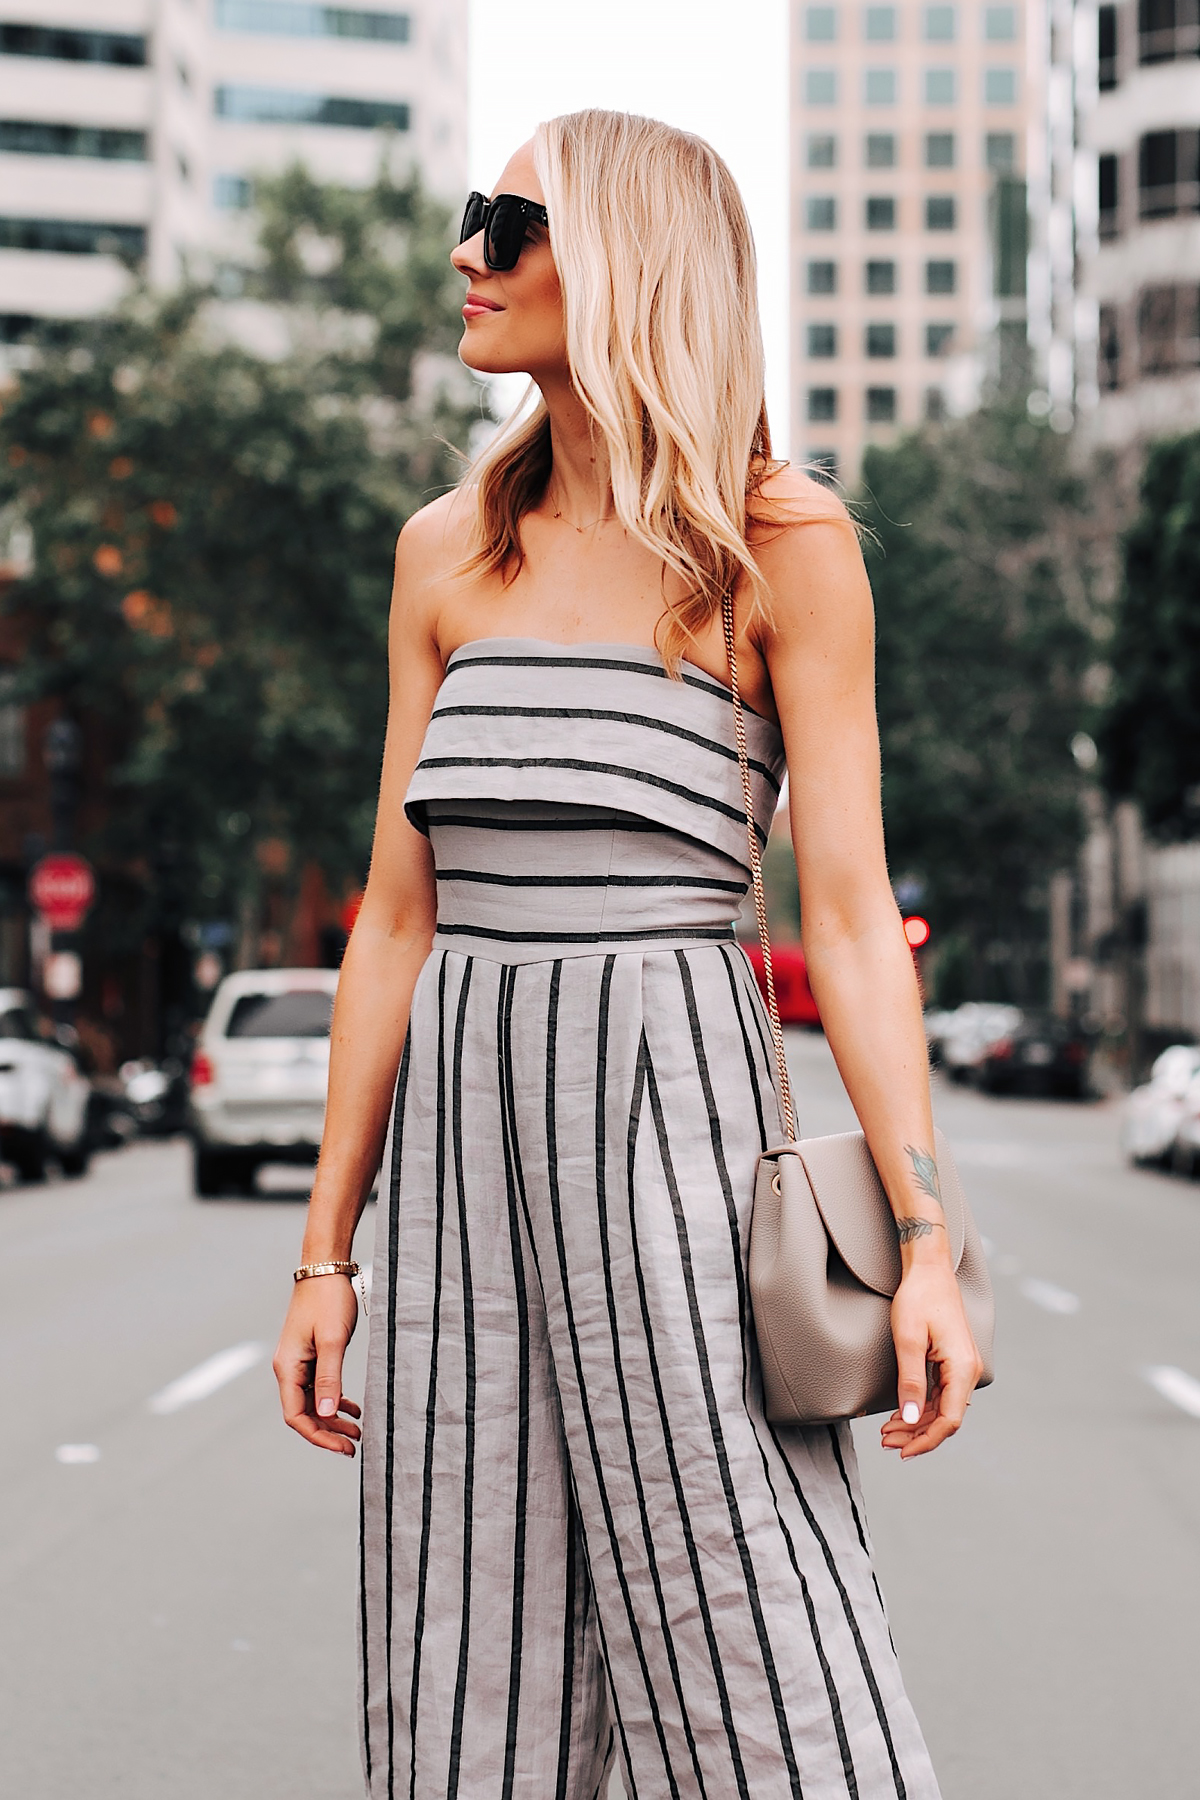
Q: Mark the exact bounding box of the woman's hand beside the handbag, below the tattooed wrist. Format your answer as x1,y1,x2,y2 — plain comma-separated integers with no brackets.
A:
883,1258,982,1460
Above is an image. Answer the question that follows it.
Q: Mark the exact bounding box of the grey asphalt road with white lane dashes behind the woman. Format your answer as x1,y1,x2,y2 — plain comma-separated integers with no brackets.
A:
0,1037,1200,1800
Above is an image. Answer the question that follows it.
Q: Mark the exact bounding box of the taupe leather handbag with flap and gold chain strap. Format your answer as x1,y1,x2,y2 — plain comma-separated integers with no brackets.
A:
721,598,995,1424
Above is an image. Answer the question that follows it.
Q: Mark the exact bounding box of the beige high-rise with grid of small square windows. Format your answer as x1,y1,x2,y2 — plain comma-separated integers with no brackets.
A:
790,0,1072,484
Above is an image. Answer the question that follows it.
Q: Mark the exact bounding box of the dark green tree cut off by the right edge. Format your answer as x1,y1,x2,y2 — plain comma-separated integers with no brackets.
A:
1097,432,1200,837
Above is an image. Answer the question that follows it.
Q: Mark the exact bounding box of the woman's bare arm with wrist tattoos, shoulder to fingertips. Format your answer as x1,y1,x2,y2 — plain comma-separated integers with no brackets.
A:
759,475,979,1456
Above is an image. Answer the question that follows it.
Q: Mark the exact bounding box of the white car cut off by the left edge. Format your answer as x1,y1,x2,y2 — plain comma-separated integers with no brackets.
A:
0,988,92,1181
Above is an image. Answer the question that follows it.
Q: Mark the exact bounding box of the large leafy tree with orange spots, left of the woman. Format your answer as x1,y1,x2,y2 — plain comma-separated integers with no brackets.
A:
0,169,479,993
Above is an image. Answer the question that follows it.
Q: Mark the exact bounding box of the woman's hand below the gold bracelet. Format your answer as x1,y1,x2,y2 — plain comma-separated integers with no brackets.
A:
273,1274,362,1456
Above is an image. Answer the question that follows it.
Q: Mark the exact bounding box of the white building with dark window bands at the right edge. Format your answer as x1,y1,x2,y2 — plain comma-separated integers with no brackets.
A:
1078,0,1200,448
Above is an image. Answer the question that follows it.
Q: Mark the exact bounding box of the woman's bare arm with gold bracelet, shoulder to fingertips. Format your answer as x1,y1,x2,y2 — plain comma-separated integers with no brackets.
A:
275,502,455,1456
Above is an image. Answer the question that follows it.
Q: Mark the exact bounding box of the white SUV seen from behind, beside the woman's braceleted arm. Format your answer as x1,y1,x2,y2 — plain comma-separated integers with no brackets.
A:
187,968,338,1199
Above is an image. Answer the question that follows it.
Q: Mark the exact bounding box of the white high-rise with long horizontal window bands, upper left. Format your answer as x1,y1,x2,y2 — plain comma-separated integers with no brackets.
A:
0,0,466,338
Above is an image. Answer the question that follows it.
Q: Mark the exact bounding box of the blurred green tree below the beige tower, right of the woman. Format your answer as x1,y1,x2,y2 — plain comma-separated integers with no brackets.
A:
862,403,1105,1001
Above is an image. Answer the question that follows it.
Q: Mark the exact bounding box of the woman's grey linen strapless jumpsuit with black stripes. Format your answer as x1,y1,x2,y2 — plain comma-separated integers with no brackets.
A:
360,639,937,1800
